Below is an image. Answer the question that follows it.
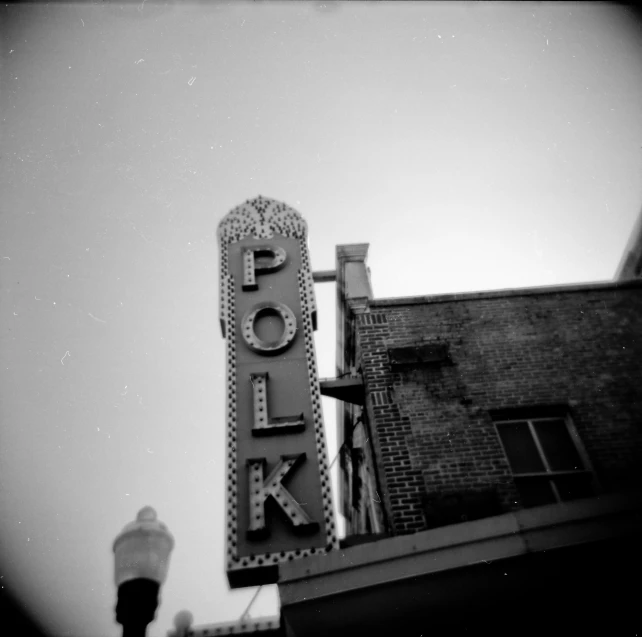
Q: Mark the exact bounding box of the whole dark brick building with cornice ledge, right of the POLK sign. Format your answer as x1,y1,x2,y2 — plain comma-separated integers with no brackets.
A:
279,232,642,635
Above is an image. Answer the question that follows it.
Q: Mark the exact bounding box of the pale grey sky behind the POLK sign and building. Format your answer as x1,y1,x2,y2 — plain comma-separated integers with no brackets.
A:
0,0,642,637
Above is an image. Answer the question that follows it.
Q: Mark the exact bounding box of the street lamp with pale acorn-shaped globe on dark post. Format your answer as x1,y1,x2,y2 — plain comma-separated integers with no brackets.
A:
113,506,174,637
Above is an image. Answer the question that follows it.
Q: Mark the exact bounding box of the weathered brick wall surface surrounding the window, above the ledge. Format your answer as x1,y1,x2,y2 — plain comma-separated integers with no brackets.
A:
356,284,642,534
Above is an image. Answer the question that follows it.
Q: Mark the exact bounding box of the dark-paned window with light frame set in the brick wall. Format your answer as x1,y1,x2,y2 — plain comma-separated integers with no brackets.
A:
495,416,595,507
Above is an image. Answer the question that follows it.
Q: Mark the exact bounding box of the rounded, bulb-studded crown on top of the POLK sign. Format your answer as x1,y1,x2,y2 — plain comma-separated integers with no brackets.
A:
218,195,308,244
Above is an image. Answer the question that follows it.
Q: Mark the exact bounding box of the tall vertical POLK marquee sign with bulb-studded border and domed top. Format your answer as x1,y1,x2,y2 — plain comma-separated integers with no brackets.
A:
218,197,338,588
